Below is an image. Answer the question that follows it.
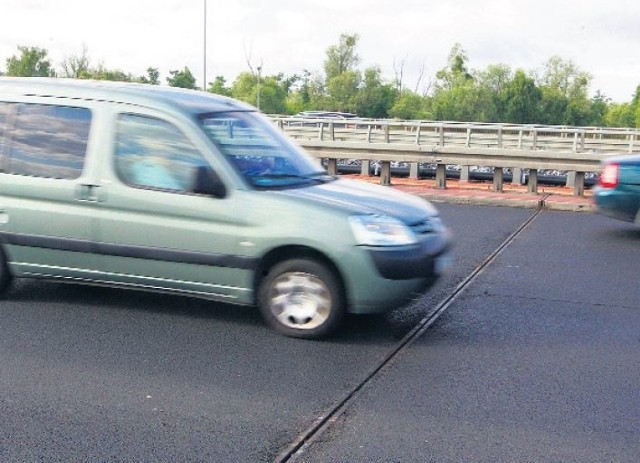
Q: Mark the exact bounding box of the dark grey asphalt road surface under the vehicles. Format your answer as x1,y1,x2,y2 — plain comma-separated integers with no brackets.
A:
0,204,640,463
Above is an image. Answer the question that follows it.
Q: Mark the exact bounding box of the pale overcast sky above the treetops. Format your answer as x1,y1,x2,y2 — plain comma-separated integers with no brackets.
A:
0,0,640,103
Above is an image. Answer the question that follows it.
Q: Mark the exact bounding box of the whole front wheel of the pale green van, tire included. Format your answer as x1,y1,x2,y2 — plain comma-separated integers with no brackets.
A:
258,259,345,339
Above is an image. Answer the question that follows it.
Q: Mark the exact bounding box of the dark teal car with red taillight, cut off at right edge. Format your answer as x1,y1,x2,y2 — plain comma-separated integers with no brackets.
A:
595,155,640,225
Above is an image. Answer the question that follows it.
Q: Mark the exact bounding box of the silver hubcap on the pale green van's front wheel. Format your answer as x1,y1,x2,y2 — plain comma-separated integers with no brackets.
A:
270,272,331,329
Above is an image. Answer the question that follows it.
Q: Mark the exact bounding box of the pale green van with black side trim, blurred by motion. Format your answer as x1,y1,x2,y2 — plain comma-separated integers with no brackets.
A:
0,78,450,338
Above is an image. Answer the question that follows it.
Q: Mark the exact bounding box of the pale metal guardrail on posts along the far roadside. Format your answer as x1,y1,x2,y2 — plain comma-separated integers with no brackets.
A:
272,116,640,195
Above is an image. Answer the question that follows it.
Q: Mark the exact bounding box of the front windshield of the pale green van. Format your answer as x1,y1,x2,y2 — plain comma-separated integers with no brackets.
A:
199,111,334,189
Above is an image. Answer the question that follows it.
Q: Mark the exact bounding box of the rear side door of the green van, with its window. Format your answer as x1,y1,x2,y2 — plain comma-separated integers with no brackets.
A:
0,102,99,279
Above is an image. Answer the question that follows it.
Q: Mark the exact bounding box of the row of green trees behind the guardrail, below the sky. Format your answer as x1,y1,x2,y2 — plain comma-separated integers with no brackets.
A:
0,39,640,127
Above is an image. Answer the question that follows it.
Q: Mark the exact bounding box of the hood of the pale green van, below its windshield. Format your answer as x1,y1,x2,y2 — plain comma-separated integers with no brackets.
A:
279,179,438,223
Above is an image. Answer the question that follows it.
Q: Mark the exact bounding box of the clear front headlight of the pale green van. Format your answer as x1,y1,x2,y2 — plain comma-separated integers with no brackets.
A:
349,214,418,246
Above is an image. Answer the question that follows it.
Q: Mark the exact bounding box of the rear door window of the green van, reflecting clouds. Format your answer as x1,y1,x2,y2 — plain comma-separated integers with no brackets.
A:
4,104,91,179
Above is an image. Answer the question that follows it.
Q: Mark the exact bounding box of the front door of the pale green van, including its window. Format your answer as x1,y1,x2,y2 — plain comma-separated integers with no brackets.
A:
98,113,252,302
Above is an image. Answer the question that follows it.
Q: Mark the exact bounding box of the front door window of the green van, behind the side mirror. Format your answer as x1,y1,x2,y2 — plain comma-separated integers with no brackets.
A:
115,114,207,193
